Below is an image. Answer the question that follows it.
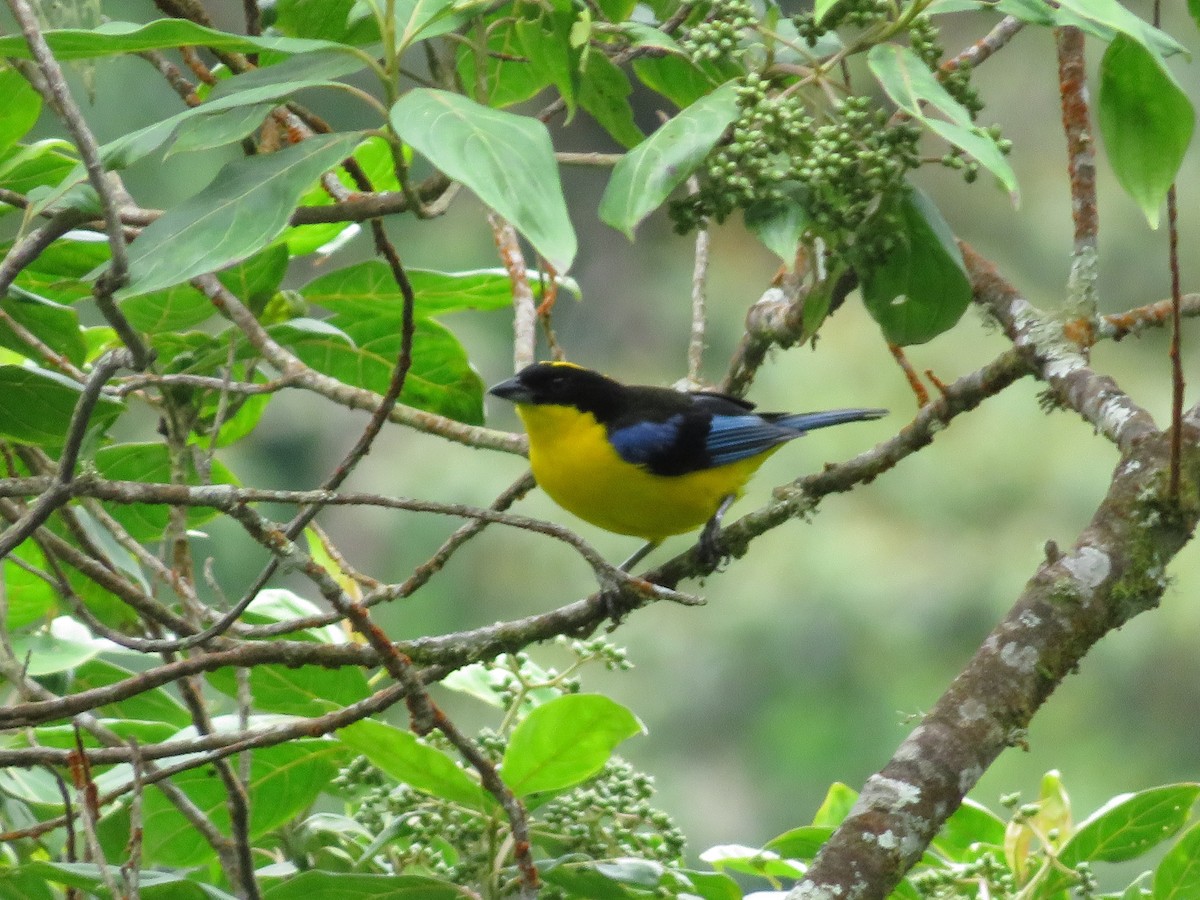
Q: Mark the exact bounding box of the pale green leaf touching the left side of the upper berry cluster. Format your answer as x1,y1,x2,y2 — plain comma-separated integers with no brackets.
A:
600,82,738,240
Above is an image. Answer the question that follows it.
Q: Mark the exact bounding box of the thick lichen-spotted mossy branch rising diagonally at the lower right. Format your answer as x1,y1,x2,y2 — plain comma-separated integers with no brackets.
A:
790,426,1200,900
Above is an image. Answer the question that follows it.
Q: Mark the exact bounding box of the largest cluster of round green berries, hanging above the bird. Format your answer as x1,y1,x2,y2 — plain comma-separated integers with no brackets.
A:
671,80,920,271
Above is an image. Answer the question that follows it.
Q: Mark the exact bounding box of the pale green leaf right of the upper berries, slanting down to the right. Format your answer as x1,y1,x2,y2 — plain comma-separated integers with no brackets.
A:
866,43,1018,203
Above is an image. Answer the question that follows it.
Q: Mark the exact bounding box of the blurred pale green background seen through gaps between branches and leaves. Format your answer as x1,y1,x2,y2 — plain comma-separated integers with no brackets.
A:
16,0,1200,878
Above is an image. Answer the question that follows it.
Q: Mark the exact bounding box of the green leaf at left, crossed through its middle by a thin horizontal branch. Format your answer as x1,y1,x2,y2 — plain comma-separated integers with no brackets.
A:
95,443,238,541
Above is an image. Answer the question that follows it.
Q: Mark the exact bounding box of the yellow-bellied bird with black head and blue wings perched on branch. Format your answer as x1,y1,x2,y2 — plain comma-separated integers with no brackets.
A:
488,361,887,571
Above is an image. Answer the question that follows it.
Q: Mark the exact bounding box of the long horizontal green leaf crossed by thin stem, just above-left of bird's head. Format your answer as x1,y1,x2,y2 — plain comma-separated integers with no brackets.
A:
301,259,578,319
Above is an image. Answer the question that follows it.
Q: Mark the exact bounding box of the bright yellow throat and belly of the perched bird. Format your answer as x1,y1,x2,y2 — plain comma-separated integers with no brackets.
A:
517,406,774,541
